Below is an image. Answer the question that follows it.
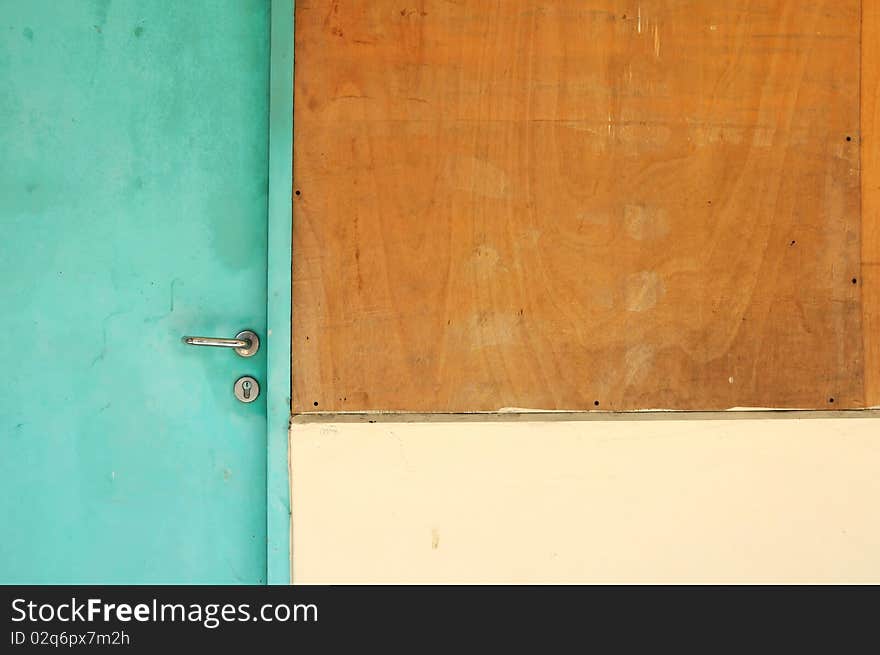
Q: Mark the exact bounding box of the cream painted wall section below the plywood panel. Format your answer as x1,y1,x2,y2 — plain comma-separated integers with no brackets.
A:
291,418,880,584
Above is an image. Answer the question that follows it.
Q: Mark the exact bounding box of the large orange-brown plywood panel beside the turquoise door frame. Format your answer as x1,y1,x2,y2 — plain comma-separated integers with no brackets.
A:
292,0,866,412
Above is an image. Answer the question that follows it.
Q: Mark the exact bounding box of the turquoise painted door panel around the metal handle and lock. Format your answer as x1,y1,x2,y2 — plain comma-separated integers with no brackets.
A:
0,0,269,583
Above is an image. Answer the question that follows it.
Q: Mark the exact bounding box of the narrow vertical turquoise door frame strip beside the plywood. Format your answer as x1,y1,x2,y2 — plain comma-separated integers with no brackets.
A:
266,0,294,585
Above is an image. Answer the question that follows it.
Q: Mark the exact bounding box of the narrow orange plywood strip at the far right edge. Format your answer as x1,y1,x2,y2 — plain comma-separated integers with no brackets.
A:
861,0,880,406
